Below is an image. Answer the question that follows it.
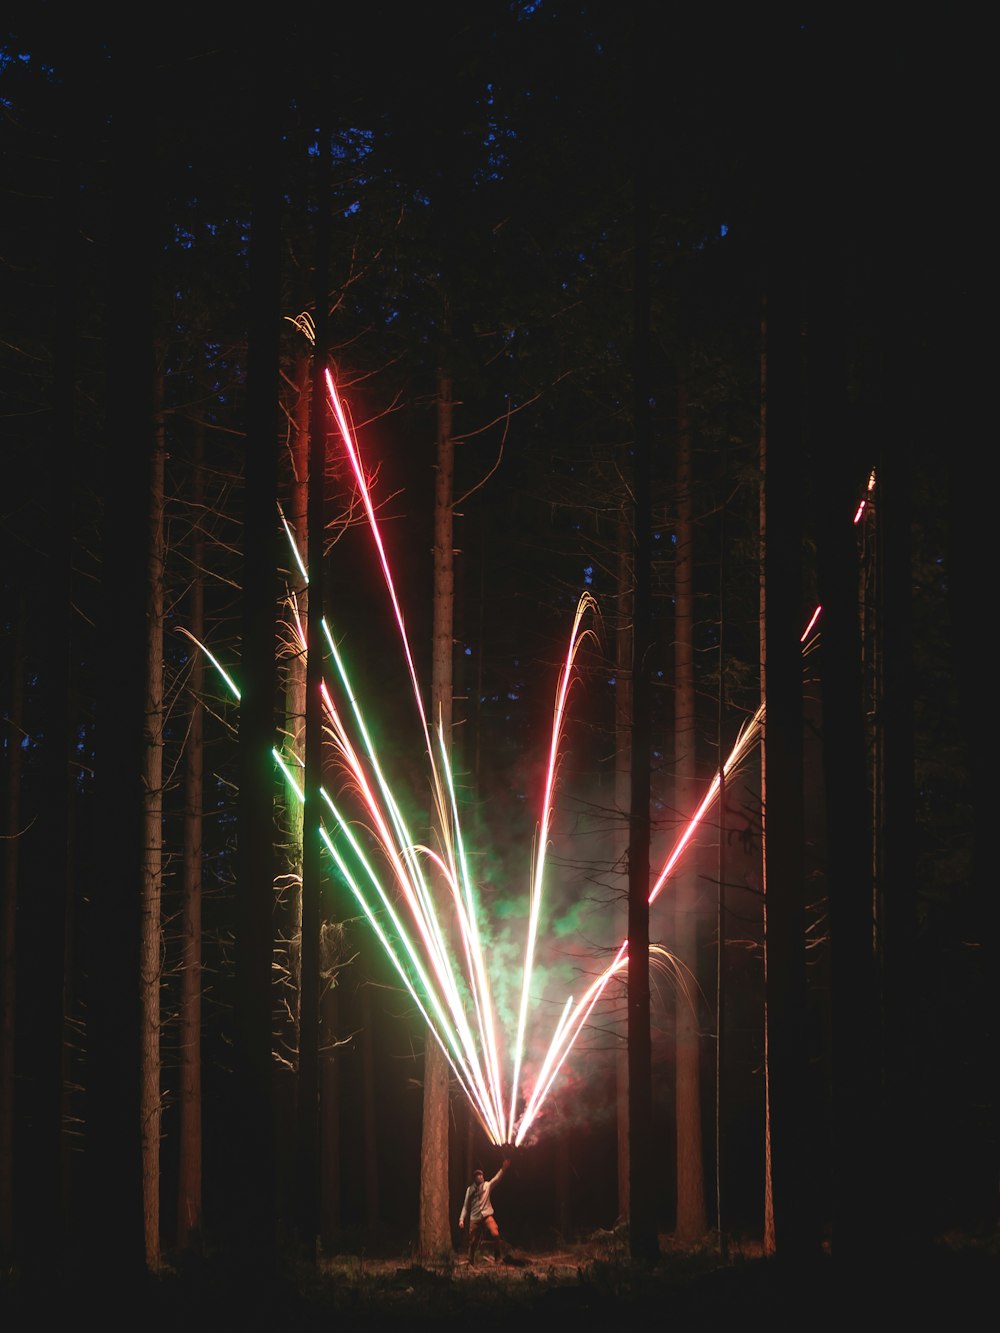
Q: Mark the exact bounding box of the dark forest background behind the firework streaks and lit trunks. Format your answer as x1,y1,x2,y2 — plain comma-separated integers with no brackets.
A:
0,0,997,1290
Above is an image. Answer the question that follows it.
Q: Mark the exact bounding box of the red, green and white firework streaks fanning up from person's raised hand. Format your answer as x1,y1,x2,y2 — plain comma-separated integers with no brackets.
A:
192,372,832,1146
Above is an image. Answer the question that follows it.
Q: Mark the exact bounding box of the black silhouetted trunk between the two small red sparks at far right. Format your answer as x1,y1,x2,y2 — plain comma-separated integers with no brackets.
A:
808,207,874,1258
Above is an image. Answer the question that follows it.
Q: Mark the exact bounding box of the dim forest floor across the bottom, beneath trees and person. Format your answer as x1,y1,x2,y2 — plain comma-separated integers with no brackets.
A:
0,1233,1000,1333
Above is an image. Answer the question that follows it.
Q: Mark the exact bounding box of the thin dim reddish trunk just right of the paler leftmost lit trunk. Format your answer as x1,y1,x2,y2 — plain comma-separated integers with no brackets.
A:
177,423,205,1253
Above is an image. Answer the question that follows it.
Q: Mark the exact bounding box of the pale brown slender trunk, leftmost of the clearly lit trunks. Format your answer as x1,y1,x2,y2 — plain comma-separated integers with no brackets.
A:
139,375,165,1272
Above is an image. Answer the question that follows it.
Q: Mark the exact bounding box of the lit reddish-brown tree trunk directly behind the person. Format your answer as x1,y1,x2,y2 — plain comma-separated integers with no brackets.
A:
420,371,455,1260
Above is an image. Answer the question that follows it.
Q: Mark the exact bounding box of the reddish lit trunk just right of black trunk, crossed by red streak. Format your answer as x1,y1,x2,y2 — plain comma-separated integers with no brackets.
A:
673,375,707,1241
